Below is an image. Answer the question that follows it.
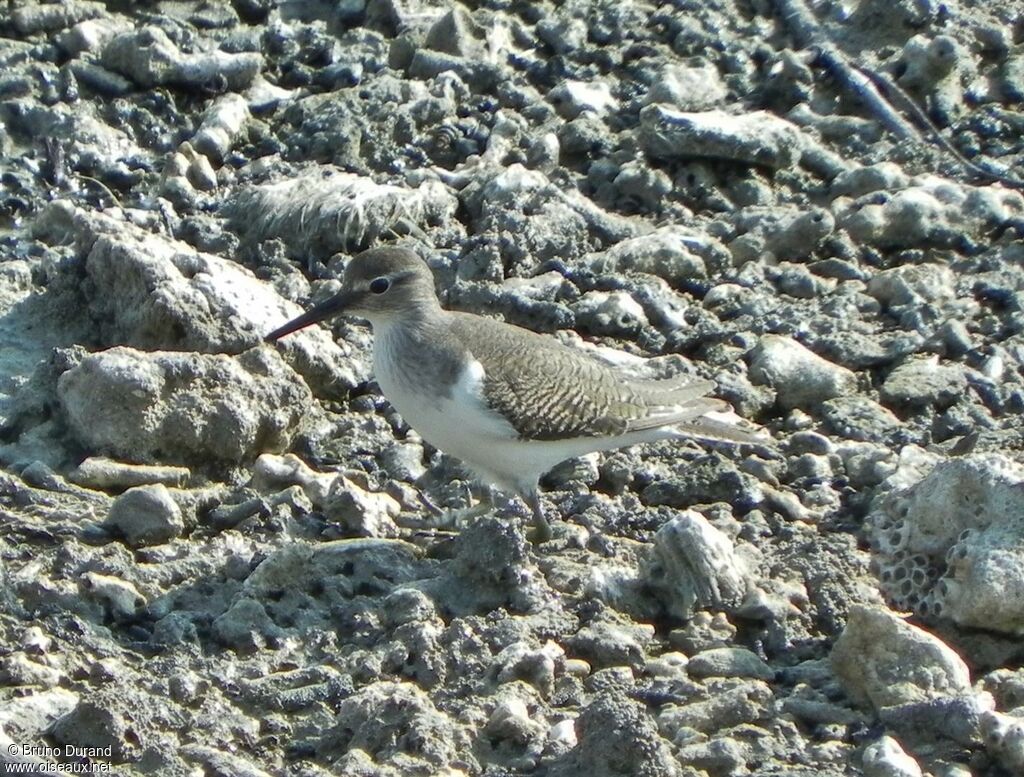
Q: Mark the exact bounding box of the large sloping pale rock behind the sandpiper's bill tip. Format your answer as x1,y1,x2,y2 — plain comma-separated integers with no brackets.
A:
37,201,365,396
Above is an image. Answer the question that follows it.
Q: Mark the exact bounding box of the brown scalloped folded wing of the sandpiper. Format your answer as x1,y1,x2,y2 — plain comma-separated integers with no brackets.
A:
452,313,726,440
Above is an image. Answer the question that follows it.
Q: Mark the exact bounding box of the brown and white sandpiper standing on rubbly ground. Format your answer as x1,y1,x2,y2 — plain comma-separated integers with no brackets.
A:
265,247,765,542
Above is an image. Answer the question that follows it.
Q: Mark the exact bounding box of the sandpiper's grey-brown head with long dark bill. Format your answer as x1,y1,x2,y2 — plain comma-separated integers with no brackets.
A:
264,246,439,342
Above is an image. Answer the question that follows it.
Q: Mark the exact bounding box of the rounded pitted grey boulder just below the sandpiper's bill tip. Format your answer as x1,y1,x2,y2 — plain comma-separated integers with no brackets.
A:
57,348,312,465
